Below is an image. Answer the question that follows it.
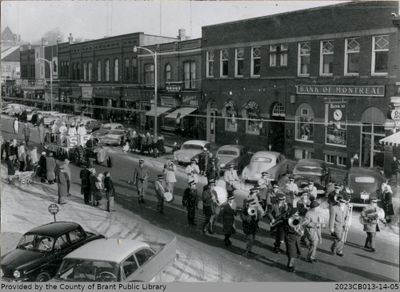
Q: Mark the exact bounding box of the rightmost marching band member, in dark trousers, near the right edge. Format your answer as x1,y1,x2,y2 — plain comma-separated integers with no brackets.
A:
361,194,384,252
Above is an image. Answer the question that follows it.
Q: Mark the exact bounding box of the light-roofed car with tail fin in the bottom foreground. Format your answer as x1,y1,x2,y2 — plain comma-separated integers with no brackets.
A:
53,238,176,282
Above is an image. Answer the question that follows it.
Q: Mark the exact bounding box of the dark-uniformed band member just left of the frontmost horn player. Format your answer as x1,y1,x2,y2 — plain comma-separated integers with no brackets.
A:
268,192,290,253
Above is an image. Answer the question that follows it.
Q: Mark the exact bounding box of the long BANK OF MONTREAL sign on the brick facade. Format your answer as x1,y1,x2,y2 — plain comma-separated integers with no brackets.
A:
296,85,385,97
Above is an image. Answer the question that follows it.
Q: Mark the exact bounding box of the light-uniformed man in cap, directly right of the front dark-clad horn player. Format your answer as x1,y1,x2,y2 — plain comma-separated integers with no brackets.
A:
303,201,322,263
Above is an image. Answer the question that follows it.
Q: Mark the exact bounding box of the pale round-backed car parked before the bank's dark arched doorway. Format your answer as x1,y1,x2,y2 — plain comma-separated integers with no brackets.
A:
242,151,289,183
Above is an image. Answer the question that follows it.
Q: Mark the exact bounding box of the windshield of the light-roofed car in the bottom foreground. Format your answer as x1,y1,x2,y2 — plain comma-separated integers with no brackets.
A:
55,259,119,282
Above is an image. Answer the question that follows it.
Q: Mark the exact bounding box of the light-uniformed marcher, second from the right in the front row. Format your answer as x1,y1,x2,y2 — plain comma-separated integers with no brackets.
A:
329,195,349,257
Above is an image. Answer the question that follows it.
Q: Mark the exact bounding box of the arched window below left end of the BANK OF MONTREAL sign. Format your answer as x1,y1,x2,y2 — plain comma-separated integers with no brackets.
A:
295,103,314,142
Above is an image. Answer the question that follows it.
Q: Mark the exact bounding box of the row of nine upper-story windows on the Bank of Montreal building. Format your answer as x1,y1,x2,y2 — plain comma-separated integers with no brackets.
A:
206,35,389,78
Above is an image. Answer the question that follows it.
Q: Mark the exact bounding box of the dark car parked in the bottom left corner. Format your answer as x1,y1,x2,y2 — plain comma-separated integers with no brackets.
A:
1,222,104,282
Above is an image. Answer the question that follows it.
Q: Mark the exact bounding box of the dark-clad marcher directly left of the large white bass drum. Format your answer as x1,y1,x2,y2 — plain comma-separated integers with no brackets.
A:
202,180,218,234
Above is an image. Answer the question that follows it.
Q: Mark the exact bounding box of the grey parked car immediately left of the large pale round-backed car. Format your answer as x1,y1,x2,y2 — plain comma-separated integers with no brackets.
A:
216,145,250,174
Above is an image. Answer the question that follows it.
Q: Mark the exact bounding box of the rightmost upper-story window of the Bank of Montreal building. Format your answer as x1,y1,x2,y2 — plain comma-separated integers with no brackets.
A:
371,35,389,75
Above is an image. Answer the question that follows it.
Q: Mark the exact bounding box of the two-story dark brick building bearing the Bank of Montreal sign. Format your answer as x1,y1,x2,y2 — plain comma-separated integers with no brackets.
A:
201,1,400,171
